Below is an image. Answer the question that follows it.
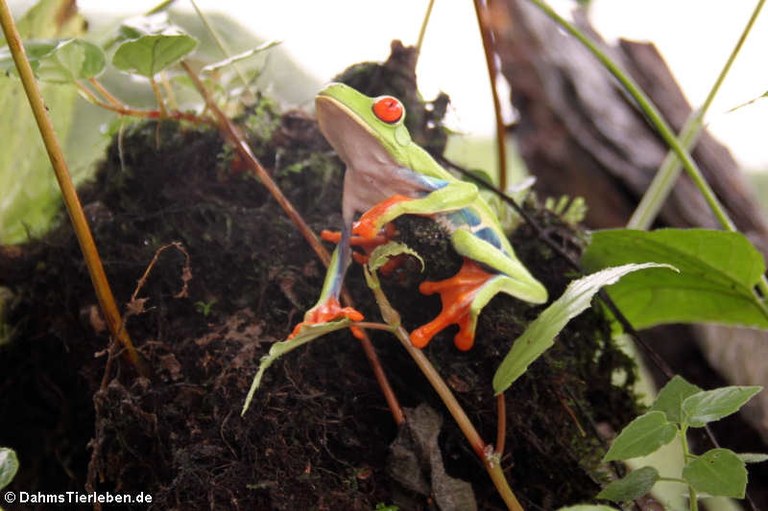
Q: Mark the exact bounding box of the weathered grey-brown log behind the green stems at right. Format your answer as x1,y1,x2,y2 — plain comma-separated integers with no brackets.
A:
489,0,768,441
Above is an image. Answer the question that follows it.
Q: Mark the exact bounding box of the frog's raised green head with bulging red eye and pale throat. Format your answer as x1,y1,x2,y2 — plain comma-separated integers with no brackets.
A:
315,83,411,169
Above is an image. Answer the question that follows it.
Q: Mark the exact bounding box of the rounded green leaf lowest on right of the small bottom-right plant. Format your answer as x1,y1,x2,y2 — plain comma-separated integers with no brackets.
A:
683,449,747,499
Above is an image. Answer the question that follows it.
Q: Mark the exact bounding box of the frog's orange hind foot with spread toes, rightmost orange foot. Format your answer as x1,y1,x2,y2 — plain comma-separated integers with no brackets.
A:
411,259,494,351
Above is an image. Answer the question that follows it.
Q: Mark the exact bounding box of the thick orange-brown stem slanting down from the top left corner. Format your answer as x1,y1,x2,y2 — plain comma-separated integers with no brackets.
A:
0,0,145,373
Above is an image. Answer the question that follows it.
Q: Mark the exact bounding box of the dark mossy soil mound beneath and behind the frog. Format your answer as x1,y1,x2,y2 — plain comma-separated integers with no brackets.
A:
0,83,637,510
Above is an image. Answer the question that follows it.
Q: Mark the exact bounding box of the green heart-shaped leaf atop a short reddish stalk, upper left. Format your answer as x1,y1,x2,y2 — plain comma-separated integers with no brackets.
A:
112,33,197,78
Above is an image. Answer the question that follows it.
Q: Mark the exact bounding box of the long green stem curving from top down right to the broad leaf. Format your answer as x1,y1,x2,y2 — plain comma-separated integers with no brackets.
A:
529,0,768,298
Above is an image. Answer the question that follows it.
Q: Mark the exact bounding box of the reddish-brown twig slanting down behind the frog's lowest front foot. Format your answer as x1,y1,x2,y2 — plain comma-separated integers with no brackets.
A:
181,61,405,424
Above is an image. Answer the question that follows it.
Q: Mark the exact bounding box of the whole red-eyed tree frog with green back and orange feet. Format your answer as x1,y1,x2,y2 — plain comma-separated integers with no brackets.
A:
294,83,547,350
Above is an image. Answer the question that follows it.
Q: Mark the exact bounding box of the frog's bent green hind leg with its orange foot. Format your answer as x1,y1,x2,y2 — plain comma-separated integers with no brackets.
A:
411,230,547,351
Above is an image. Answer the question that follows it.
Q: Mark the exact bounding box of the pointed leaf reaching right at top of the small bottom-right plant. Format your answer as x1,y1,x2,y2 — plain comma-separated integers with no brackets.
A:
683,386,763,428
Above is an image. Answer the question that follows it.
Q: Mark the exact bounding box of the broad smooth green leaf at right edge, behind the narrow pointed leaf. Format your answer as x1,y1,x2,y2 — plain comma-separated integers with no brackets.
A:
582,229,768,328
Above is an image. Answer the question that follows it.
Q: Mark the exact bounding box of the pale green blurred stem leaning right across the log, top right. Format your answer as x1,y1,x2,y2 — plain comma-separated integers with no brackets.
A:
627,0,765,230
